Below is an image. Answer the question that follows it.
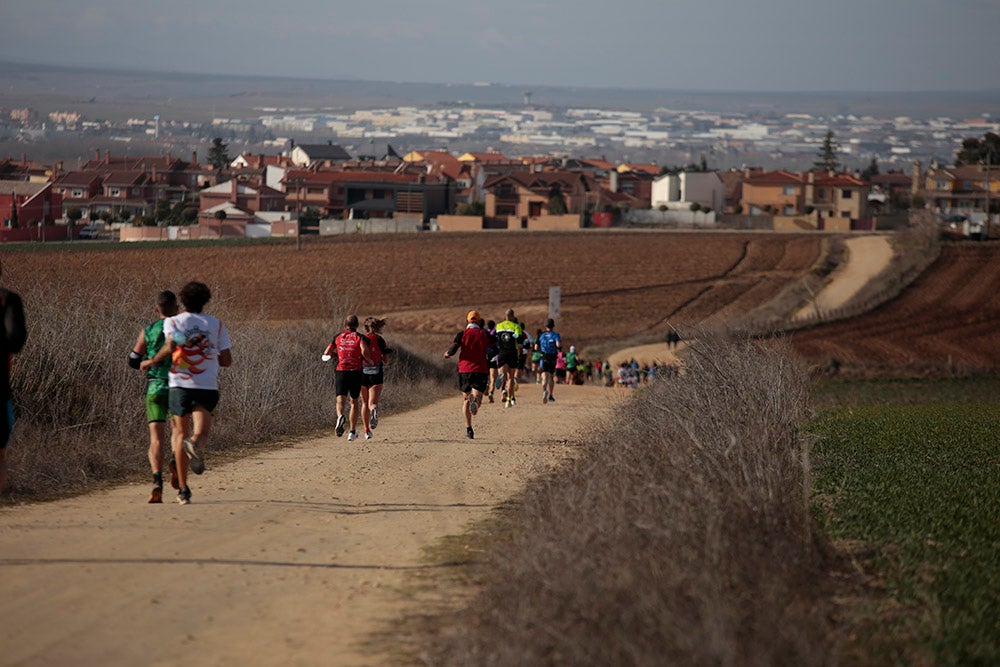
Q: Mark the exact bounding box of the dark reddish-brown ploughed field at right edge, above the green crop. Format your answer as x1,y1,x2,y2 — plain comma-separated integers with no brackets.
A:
791,243,1000,371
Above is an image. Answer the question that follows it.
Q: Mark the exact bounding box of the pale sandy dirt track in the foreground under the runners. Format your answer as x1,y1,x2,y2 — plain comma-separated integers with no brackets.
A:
0,384,627,665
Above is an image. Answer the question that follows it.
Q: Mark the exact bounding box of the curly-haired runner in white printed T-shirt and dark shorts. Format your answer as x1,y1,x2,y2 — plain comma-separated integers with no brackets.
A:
140,282,233,505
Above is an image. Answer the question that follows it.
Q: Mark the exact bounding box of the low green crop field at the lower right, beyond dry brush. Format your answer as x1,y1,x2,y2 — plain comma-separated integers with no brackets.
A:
811,378,1000,664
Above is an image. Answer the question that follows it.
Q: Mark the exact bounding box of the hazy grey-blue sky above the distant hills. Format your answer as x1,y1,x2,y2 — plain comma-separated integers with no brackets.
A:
0,0,1000,91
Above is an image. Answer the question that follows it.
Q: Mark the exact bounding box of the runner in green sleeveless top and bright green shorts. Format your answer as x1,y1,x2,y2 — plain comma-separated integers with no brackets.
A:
128,290,180,503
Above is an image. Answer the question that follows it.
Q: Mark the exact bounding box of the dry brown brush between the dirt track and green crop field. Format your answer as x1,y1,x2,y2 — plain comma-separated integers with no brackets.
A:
431,340,832,665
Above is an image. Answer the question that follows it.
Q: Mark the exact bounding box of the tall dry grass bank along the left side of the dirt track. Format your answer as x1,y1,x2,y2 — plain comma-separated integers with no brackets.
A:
4,272,452,501
